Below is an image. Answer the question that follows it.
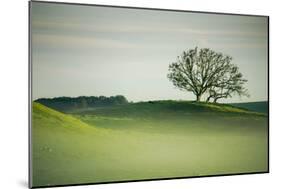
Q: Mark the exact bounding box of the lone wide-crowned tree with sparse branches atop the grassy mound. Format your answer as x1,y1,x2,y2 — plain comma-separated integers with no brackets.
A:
167,47,248,102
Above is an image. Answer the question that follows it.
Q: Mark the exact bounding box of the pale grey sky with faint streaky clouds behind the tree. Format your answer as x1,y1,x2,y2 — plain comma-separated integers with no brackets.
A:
31,2,268,102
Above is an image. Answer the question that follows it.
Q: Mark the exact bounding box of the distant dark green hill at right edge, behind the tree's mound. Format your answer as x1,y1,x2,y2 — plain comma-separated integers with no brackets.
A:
230,101,268,114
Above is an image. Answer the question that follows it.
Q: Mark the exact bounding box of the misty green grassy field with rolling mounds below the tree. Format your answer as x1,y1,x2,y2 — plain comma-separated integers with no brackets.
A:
32,101,268,186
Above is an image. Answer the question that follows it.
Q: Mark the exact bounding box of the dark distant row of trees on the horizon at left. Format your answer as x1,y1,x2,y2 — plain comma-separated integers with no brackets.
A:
35,95,128,112
